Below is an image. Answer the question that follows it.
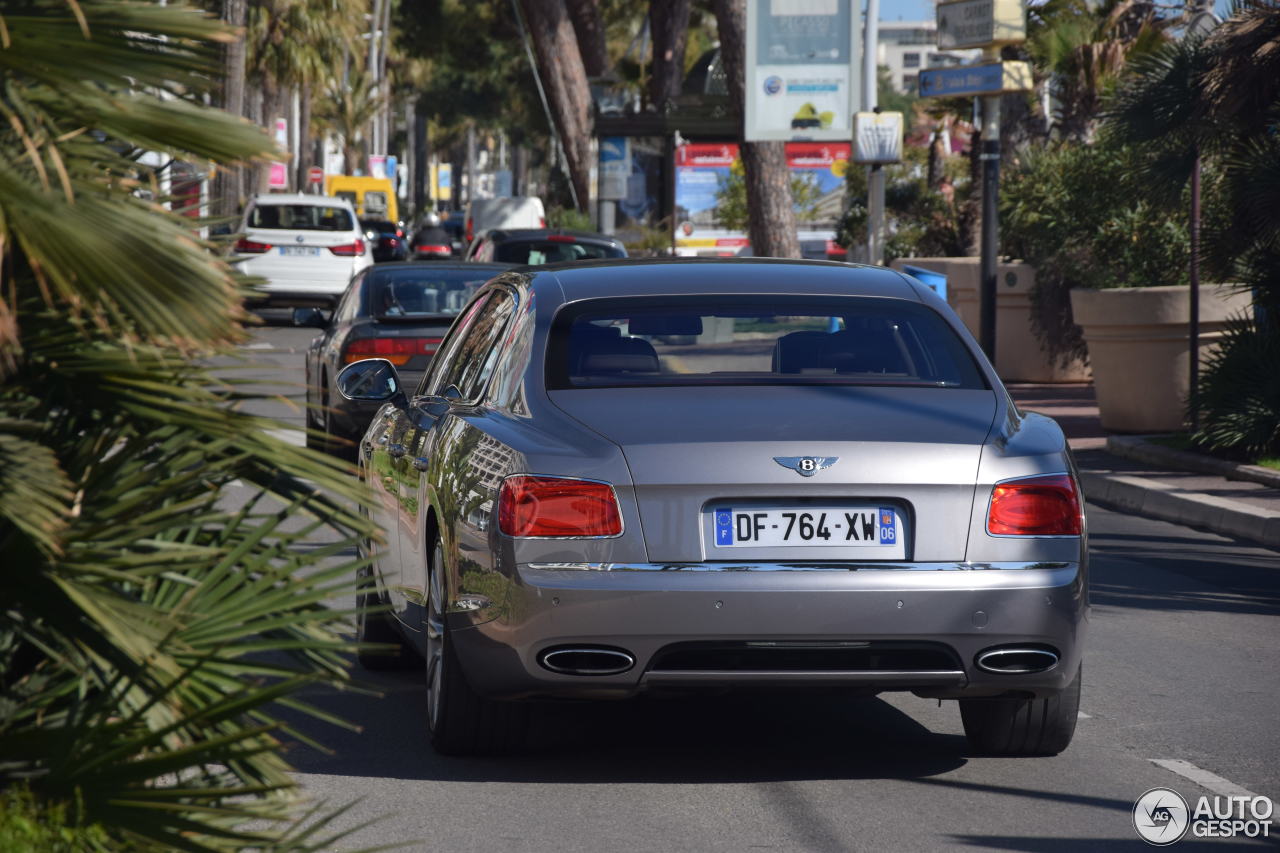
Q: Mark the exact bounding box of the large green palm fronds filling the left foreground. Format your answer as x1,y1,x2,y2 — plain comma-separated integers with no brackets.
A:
0,0,378,850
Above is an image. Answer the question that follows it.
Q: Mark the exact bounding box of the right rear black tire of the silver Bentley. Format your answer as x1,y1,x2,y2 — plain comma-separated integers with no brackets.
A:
960,669,1080,756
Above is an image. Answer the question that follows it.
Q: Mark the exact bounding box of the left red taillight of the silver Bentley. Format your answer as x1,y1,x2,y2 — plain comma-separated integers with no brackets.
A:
498,476,622,537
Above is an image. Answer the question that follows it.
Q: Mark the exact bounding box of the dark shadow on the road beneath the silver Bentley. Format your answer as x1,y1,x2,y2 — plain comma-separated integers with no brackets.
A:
288,669,968,784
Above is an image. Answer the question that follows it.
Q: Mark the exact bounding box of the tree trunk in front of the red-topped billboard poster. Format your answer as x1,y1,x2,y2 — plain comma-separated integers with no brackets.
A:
713,0,800,257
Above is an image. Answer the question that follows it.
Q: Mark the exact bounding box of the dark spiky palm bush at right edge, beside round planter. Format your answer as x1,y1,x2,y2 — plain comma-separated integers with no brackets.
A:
1190,313,1280,461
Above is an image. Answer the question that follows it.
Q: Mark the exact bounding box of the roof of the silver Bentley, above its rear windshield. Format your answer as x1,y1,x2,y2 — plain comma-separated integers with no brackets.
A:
521,257,922,302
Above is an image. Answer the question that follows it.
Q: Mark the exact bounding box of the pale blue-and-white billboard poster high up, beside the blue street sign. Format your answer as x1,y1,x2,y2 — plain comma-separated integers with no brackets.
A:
744,0,861,141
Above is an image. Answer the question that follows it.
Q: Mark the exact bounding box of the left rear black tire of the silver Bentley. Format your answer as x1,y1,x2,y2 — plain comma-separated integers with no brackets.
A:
424,538,529,756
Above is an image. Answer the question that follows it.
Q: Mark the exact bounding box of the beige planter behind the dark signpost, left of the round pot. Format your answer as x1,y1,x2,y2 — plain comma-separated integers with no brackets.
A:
891,257,1089,382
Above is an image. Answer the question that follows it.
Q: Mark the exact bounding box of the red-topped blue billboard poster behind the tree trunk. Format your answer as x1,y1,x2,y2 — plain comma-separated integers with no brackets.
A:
676,142,851,256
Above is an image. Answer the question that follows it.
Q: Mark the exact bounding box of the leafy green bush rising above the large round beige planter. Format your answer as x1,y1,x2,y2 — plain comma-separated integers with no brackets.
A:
1000,143,1190,362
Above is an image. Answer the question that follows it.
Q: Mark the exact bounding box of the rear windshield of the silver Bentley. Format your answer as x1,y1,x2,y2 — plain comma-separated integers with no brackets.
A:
547,296,988,388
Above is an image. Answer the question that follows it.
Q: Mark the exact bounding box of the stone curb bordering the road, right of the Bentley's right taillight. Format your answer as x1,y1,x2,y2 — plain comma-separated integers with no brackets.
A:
1080,471,1280,548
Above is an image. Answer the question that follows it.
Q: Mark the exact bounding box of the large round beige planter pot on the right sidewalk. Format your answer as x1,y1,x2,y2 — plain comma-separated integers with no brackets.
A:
1071,284,1249,433
